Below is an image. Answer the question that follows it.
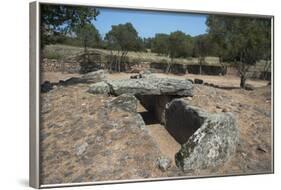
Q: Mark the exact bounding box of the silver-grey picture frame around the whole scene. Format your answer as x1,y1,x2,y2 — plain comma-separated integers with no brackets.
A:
29,0,275,189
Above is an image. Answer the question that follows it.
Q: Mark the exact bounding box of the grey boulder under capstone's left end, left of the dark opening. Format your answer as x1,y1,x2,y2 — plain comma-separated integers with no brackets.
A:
107,94,138,112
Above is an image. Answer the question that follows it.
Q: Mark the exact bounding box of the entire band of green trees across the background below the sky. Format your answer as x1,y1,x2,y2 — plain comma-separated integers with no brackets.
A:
40,4,271,83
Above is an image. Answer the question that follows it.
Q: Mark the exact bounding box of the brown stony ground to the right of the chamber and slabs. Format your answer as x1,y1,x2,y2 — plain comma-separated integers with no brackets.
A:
182,85,272,174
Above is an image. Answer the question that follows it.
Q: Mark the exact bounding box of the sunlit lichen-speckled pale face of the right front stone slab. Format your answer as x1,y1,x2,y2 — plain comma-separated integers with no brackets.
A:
176,110,239,172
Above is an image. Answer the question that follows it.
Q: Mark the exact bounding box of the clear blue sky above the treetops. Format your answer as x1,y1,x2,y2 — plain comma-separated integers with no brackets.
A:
92,8,207,37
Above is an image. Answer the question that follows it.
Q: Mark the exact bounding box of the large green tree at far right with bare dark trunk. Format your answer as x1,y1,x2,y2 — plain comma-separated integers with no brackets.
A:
206,15,271,88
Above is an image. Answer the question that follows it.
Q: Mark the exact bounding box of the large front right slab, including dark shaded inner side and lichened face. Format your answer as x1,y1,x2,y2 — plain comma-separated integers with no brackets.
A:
165,99,239,172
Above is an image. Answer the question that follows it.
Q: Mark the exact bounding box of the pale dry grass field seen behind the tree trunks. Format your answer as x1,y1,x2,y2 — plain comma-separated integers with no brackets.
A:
43,44,271,78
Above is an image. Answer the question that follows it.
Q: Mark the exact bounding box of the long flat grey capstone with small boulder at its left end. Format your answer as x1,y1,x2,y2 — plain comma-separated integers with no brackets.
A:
88,77,193,96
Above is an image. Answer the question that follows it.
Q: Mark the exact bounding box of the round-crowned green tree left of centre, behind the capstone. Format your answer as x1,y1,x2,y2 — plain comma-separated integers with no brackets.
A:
105,23,142,72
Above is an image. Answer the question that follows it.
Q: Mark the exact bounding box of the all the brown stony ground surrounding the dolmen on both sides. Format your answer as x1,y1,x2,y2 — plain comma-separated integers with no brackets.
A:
40,73,272,184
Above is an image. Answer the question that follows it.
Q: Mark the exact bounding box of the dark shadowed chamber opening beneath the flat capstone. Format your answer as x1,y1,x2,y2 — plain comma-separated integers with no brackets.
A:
136,95,202,144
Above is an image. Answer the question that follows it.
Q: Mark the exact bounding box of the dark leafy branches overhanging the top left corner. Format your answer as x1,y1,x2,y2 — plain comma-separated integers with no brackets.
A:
40,4,99,48
